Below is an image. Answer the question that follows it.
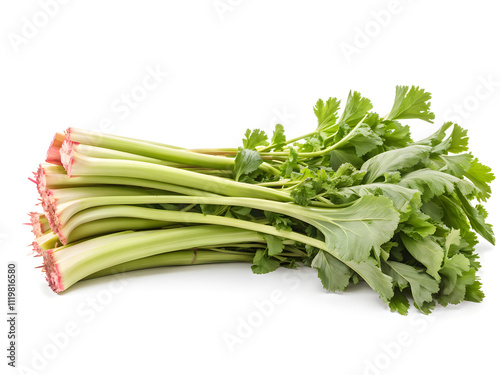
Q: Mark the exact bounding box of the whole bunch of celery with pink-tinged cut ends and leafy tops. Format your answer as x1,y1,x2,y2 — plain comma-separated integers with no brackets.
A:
30,86,494,314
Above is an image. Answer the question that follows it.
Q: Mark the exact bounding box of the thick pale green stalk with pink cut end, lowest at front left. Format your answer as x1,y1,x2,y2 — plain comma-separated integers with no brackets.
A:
43,225,263,292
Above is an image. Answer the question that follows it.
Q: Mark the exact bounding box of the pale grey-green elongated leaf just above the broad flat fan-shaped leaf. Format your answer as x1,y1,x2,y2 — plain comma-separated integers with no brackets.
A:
361,146,431,184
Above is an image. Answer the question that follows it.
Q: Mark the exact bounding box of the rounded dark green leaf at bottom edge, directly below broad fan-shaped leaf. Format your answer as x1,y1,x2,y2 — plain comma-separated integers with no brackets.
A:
311,250,352,292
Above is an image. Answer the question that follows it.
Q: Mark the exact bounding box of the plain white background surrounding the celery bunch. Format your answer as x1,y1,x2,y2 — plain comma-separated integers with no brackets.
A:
0,0,500,375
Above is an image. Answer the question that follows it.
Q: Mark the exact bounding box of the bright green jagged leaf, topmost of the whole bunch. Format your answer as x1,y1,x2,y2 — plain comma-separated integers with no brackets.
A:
386,86,435,122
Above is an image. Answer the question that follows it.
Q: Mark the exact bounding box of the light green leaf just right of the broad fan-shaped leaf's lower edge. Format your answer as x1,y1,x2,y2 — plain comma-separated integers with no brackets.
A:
401,234,444,280
